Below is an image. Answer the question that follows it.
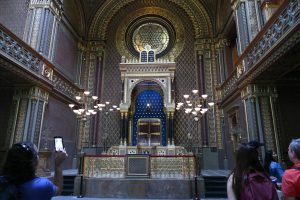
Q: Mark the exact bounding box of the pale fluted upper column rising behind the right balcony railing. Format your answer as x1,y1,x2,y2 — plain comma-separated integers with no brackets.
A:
232,0,262,54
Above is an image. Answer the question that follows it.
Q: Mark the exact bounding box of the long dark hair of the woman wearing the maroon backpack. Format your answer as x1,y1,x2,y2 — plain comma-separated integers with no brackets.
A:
231,144,265,200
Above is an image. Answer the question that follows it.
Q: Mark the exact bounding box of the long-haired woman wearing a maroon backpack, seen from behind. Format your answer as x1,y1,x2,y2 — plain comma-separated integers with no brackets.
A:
227,144,278,200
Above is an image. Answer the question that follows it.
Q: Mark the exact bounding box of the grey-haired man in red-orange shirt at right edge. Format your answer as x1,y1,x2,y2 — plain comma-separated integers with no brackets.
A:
281,138,300,200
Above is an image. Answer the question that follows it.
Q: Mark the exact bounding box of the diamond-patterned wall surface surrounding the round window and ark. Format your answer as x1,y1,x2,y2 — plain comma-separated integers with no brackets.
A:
100,1,200,146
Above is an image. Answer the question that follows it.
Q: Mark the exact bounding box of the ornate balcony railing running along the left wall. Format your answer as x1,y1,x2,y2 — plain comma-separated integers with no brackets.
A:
0,24,81,99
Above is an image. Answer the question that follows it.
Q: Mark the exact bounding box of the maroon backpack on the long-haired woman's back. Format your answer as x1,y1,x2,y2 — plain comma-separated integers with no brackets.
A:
241,172,278,200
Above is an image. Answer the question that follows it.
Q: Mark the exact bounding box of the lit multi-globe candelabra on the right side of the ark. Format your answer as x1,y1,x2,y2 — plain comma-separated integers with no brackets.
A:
176,90,215,148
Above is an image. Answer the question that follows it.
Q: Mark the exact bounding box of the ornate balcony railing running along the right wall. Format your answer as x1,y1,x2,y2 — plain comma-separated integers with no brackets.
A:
219,0,300,100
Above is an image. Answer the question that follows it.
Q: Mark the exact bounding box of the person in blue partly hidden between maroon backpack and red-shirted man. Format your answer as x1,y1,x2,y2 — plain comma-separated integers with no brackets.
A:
264,151,284,183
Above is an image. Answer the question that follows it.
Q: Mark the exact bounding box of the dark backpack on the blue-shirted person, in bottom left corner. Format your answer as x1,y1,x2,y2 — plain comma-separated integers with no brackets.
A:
0,176,18,200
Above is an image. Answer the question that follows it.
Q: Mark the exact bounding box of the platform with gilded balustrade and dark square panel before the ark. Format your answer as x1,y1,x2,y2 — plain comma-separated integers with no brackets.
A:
75,146,202,199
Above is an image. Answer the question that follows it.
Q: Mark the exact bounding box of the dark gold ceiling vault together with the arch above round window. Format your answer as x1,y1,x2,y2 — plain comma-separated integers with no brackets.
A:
64,0,232,40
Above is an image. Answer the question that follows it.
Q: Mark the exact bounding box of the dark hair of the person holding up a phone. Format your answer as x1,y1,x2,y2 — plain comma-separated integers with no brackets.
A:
2,142,38,184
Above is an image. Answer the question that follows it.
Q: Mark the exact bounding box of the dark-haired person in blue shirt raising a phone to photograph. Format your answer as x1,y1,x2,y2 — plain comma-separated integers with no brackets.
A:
0,142,67,200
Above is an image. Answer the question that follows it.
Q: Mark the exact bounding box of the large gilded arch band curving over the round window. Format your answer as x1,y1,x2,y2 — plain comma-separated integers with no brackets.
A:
89,0,212,41
